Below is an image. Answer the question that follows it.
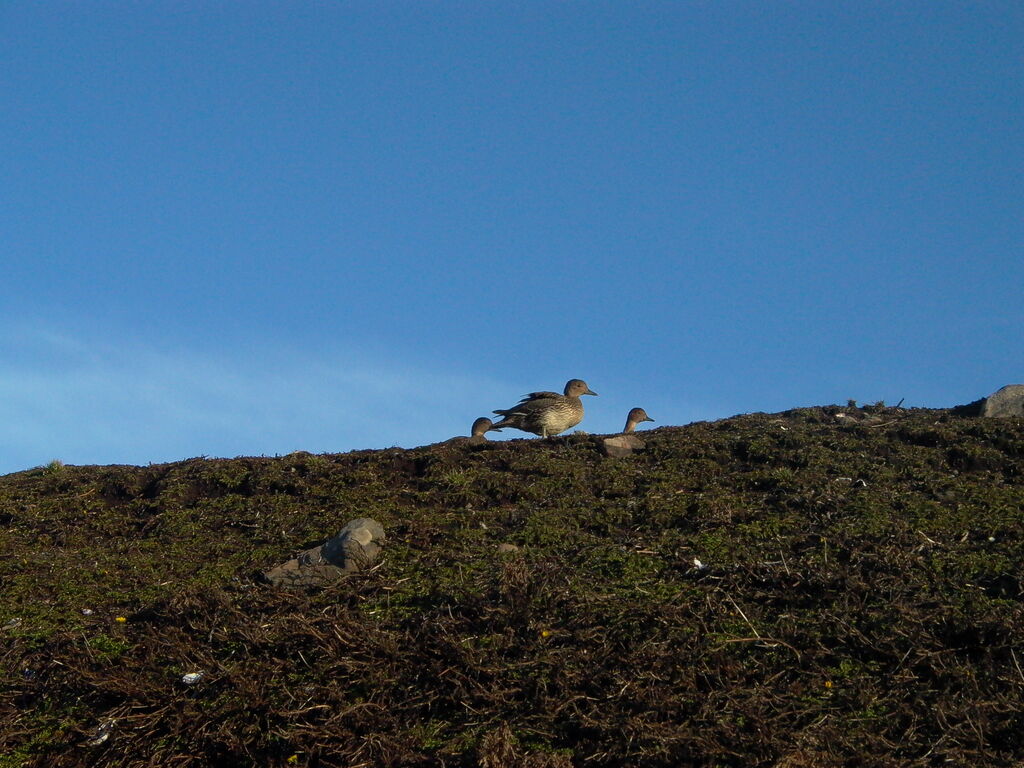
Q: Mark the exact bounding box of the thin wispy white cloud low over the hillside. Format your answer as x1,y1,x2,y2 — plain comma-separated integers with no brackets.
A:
0,329,508,473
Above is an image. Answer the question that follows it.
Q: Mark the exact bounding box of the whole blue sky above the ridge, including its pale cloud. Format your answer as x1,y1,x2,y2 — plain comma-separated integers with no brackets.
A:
0,0,1024,473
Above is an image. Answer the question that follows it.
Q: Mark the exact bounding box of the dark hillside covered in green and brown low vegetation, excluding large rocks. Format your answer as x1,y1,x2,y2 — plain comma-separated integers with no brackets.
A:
0,407,1024,768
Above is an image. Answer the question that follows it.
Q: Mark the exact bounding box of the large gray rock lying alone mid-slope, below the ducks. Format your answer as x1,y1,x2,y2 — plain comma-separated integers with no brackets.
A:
263,517,385,587
